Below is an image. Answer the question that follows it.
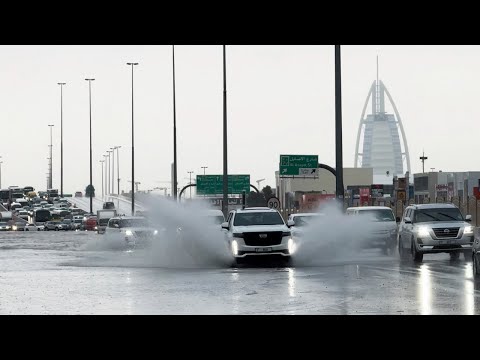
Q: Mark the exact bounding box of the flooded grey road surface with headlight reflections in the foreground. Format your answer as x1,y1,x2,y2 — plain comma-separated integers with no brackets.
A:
0,232,480,315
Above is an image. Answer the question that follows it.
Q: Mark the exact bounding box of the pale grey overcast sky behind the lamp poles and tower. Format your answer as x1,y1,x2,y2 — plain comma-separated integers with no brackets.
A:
0,45,480,195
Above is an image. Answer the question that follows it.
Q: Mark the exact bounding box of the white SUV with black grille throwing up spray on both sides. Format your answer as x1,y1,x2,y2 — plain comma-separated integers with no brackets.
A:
222,207,295,264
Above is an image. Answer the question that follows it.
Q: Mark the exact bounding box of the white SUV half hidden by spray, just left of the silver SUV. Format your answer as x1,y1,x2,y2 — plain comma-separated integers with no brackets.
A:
346,206,399,255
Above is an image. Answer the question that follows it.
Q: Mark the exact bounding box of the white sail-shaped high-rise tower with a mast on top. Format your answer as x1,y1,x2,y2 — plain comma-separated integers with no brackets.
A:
355,59,410,184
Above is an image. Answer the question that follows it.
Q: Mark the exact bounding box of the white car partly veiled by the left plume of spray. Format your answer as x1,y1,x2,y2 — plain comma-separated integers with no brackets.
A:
104,216,158,247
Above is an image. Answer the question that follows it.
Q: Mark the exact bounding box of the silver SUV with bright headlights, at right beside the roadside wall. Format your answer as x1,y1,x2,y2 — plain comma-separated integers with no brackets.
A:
398,203,474,262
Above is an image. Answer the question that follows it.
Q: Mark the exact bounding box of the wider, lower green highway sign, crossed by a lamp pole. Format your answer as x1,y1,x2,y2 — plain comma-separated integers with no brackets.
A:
197,175,250,195
